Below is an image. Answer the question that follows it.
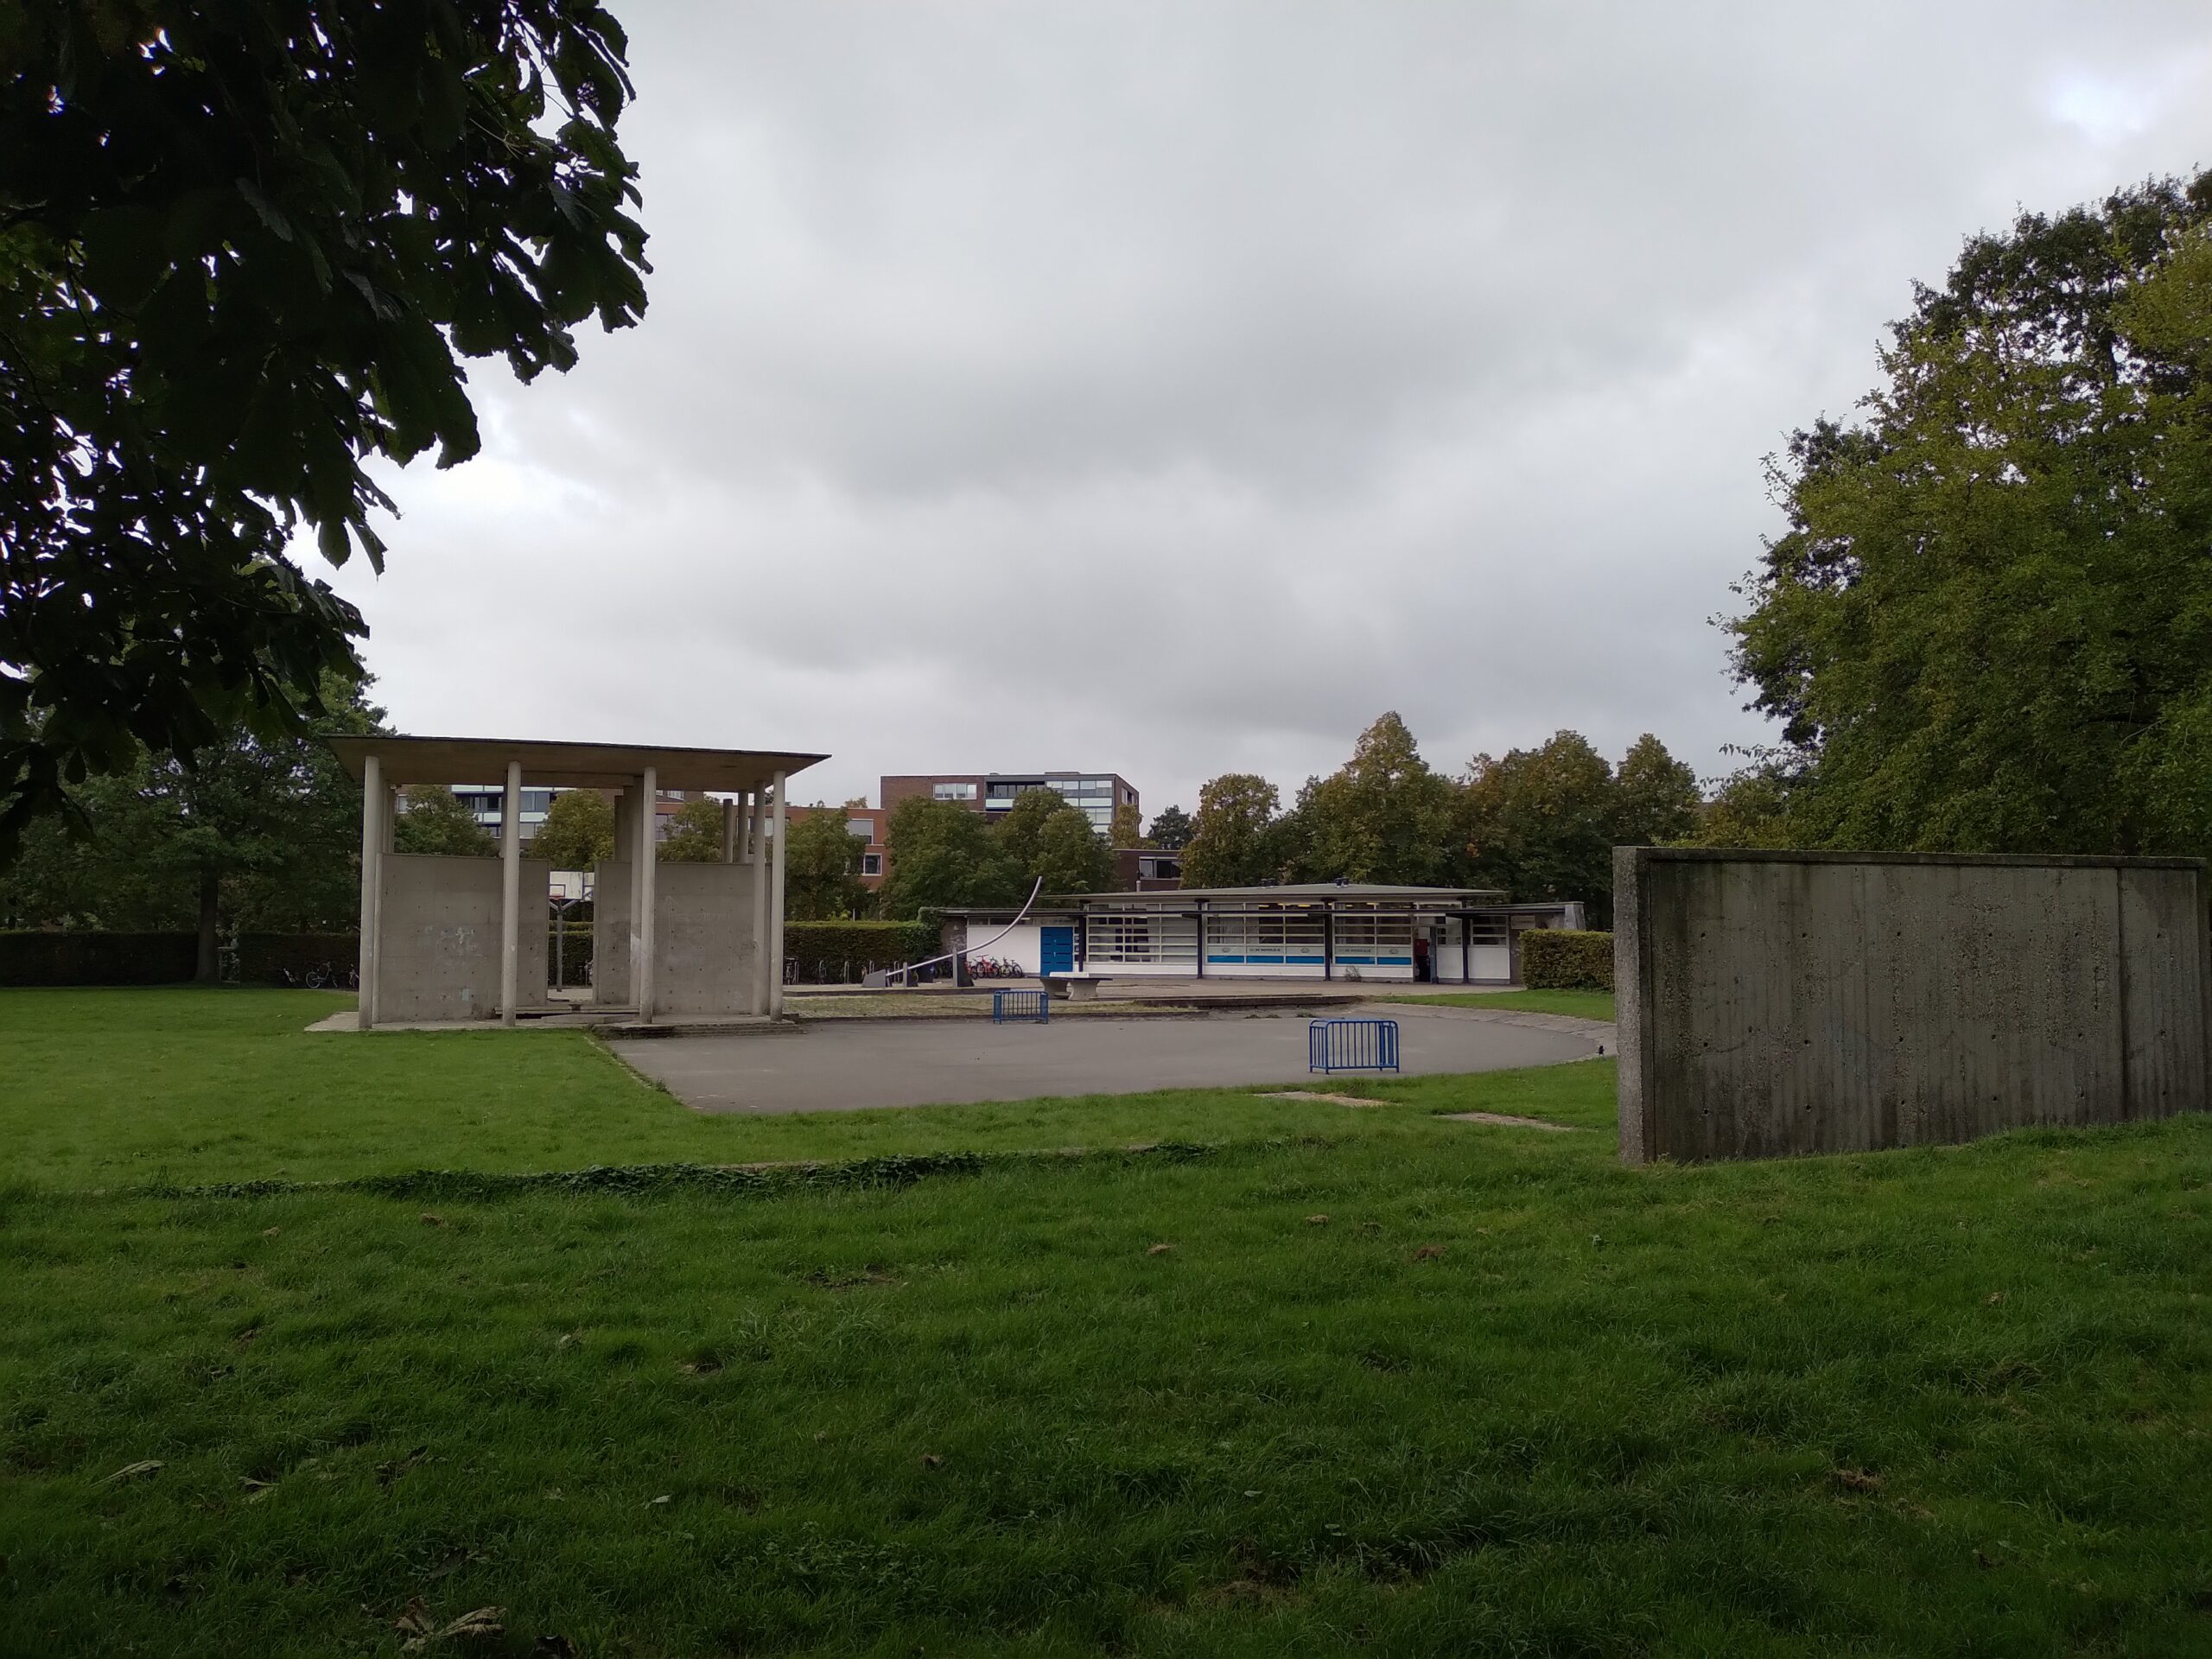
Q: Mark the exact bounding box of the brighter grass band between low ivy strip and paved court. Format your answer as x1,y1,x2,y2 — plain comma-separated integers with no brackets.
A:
0,988,1618,1190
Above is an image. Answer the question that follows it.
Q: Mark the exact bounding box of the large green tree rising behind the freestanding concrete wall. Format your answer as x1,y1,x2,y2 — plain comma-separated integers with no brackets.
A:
1730,173,2212,856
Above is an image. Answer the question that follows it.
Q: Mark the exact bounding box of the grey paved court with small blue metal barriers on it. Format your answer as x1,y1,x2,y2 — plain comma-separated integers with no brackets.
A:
613,1007,1612,1113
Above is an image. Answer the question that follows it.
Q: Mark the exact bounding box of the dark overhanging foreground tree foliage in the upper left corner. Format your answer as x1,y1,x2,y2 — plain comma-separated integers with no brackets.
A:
0,13,648,865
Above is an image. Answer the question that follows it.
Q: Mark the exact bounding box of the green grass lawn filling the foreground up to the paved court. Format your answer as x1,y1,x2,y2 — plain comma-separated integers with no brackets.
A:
0,993,2212,1655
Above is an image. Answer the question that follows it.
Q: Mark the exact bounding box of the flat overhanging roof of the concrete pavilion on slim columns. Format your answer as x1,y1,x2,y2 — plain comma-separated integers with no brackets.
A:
325,736,830,794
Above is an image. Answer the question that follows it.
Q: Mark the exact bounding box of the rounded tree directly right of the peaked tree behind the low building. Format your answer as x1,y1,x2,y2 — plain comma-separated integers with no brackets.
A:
1460,732,1615,927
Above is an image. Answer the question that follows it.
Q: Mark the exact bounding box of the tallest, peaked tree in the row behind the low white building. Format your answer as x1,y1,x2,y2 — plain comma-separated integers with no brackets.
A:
1296,712,1455,887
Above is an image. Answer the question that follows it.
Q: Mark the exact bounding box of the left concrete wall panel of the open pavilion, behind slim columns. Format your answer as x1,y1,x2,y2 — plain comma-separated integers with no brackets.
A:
376,852,553,1024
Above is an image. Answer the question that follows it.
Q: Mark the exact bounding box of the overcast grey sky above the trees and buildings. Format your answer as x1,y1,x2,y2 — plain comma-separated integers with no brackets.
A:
339,0,2212,817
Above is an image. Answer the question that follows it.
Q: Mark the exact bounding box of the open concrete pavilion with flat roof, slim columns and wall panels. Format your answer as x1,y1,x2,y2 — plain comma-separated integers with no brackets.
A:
329,736,827,1031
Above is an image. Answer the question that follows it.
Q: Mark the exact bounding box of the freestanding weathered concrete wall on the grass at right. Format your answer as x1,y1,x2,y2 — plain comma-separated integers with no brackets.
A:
1615,847,2212,1164
